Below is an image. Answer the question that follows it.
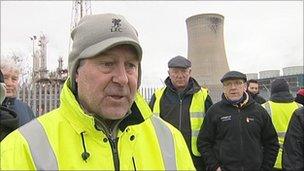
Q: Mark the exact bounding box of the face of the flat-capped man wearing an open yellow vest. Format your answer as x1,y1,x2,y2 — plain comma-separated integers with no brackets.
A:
168,68,191,90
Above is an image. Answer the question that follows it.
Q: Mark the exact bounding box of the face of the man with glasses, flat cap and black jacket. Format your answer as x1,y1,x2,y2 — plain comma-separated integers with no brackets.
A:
223,79,246,101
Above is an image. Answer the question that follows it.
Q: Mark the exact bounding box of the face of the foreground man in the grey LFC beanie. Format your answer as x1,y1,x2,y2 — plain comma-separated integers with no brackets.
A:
76,45,139,120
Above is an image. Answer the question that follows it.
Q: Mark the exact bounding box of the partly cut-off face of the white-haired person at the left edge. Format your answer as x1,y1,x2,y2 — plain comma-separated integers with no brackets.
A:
1,69,19,97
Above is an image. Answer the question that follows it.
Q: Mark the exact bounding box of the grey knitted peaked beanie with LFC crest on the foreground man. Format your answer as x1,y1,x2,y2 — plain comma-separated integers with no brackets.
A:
68,13,142,93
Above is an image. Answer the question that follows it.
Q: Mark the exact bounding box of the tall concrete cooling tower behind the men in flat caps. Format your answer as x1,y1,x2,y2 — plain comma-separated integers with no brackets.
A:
186,14,229,102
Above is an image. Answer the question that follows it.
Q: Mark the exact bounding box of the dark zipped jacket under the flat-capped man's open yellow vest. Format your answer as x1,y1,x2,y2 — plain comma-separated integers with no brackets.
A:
149,77,212,169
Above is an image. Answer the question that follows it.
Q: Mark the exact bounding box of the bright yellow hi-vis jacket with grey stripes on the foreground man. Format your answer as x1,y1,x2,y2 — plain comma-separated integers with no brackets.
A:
0,81,195,170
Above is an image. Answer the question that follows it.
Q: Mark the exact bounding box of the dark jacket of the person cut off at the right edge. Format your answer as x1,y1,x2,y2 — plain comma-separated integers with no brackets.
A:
282,107,304,171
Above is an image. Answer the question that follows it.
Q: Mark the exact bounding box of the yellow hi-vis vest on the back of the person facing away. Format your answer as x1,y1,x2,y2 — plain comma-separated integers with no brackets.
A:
262,101,301,169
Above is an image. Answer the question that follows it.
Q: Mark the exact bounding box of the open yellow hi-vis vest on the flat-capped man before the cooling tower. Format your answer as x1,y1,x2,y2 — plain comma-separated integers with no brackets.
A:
153,88,208,156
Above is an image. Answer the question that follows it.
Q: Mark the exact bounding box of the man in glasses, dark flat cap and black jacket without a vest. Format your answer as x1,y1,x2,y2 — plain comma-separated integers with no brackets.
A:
197,71,279,171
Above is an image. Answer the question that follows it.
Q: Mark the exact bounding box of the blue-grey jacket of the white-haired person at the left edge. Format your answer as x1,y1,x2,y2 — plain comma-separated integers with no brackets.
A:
2,97,35,126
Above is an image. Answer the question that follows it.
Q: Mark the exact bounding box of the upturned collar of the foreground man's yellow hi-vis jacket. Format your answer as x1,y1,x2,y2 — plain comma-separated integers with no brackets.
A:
59,78,153,134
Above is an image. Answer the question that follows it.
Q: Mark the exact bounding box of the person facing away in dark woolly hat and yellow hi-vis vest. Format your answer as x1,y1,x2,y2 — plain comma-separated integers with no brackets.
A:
262,78,301,170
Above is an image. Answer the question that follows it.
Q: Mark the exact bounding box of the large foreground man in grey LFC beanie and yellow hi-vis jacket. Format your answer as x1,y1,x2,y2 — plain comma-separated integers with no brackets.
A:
0,14,194,170
